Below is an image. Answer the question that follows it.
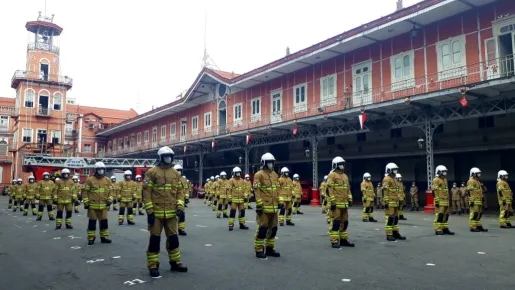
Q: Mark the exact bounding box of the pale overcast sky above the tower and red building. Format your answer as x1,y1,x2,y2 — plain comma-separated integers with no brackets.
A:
0,0,421,113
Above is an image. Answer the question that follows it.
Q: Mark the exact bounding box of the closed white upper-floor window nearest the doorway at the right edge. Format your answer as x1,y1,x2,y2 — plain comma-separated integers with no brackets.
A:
435,34,467,81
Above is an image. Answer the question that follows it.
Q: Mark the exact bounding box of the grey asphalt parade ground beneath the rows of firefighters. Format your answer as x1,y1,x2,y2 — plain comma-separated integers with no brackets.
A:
0,197,515,290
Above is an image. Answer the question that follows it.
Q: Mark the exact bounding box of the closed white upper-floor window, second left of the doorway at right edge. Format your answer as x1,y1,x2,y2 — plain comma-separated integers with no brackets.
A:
390,50,415,92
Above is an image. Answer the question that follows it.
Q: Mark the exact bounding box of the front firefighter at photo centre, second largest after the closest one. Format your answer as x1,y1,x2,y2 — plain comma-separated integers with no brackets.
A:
253,153,284,259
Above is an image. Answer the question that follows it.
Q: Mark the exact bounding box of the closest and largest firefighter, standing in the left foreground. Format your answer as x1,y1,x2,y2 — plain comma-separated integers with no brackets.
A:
143,146,188,277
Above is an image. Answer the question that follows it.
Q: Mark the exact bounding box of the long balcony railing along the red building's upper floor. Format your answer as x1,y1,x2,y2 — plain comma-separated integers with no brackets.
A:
106,55,515,156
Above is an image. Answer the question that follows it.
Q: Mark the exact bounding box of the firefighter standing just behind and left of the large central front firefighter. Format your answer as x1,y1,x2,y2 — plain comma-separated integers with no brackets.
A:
227,166,249,231
